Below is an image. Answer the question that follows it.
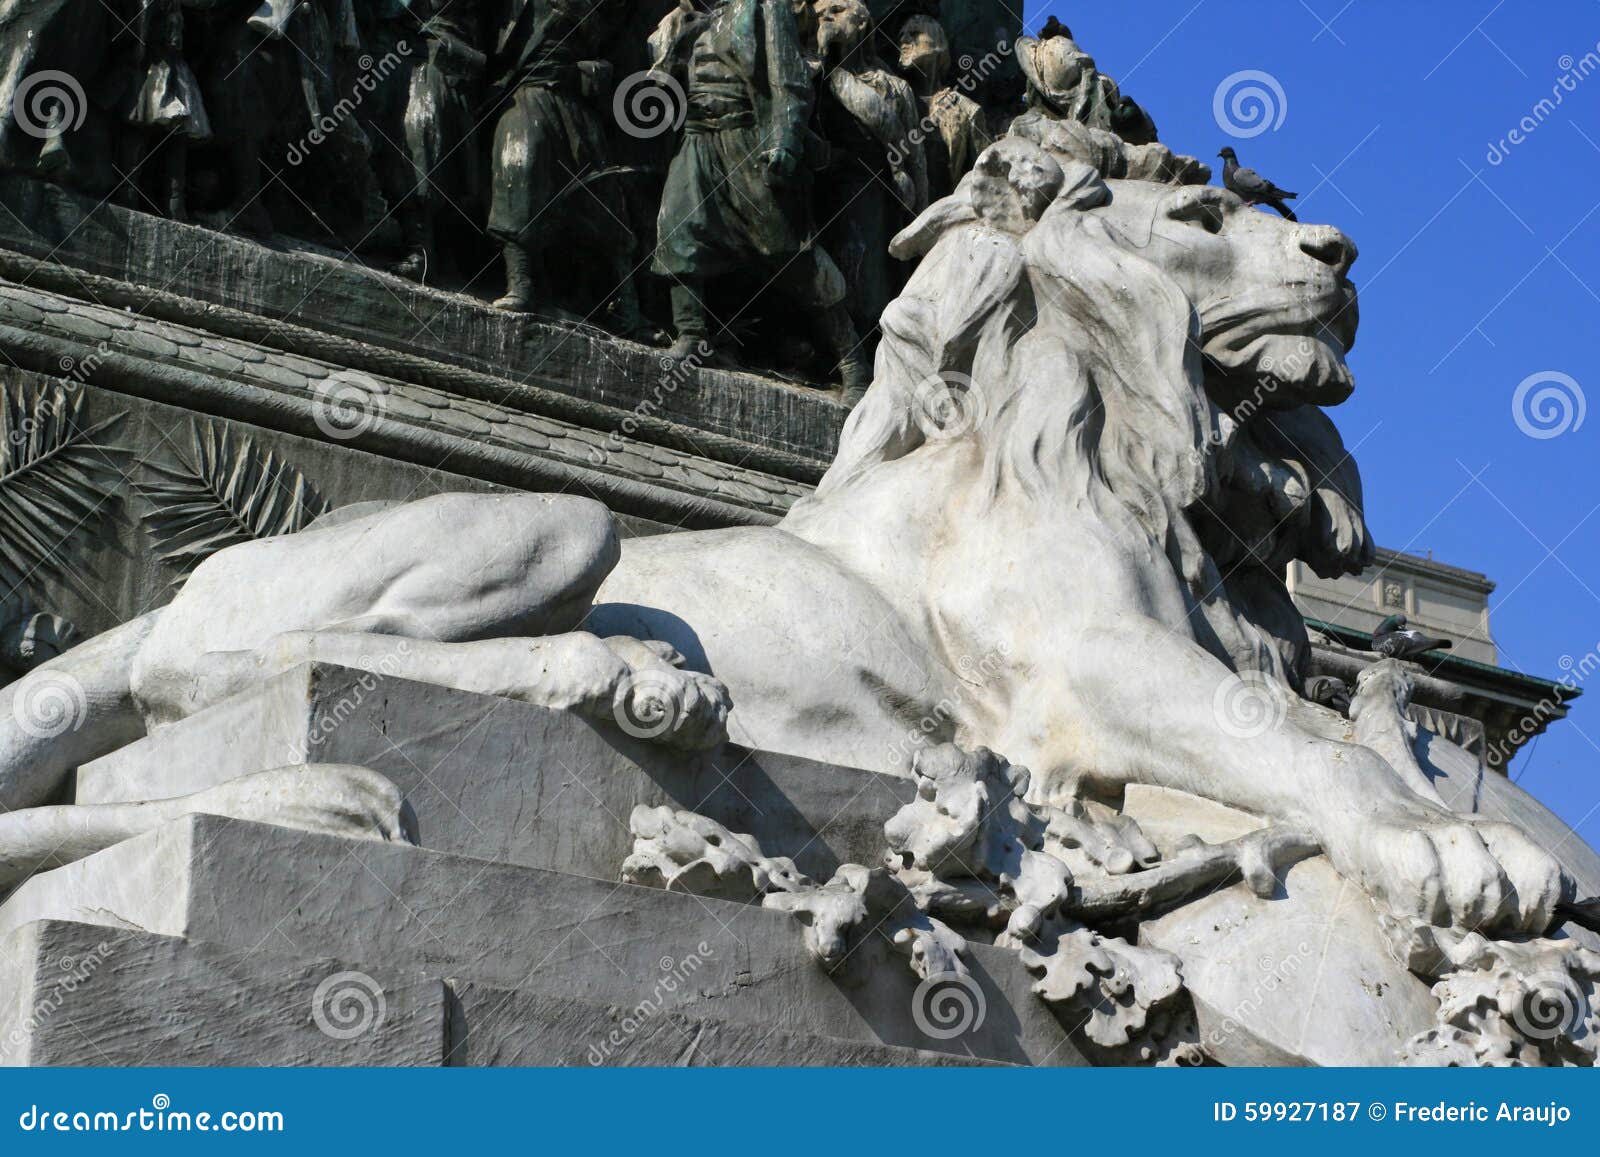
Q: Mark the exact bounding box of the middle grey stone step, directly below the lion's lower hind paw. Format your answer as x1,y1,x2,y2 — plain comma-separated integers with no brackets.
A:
0,816,1082,1064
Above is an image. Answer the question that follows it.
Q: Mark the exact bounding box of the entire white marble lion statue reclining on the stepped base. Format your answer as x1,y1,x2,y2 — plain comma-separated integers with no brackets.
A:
0,138,1571,935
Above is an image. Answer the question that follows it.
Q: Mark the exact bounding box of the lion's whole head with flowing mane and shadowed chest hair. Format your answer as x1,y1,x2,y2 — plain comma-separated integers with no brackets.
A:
797,138,1371,678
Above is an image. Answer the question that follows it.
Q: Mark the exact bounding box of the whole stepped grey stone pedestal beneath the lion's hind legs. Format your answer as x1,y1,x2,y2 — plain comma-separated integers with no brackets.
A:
0,666,1082,1064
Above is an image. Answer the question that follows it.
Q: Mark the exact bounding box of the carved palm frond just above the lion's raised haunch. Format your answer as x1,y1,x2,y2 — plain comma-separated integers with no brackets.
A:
139,422,328,586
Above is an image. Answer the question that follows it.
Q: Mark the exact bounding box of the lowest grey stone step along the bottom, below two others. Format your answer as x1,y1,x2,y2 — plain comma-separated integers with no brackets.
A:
0,920,995,1067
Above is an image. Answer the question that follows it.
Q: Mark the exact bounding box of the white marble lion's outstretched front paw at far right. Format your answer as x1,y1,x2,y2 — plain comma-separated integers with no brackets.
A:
1325,816,1562,935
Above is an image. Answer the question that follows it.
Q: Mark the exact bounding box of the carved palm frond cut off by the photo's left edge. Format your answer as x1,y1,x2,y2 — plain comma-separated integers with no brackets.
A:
0,384,128,595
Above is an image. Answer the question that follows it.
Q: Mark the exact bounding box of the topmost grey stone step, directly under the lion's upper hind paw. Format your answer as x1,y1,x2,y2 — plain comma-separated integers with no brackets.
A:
77,666,915,879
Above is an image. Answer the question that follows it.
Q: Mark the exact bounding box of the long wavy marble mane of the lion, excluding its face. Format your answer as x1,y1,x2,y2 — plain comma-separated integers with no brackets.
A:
818,145,1371,683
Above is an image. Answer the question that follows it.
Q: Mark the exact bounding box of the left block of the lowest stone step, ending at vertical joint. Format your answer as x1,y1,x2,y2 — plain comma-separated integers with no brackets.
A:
0,920,450,1066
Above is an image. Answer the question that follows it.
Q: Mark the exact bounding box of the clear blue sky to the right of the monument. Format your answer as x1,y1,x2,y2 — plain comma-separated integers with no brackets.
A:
1026,0,1600,845
